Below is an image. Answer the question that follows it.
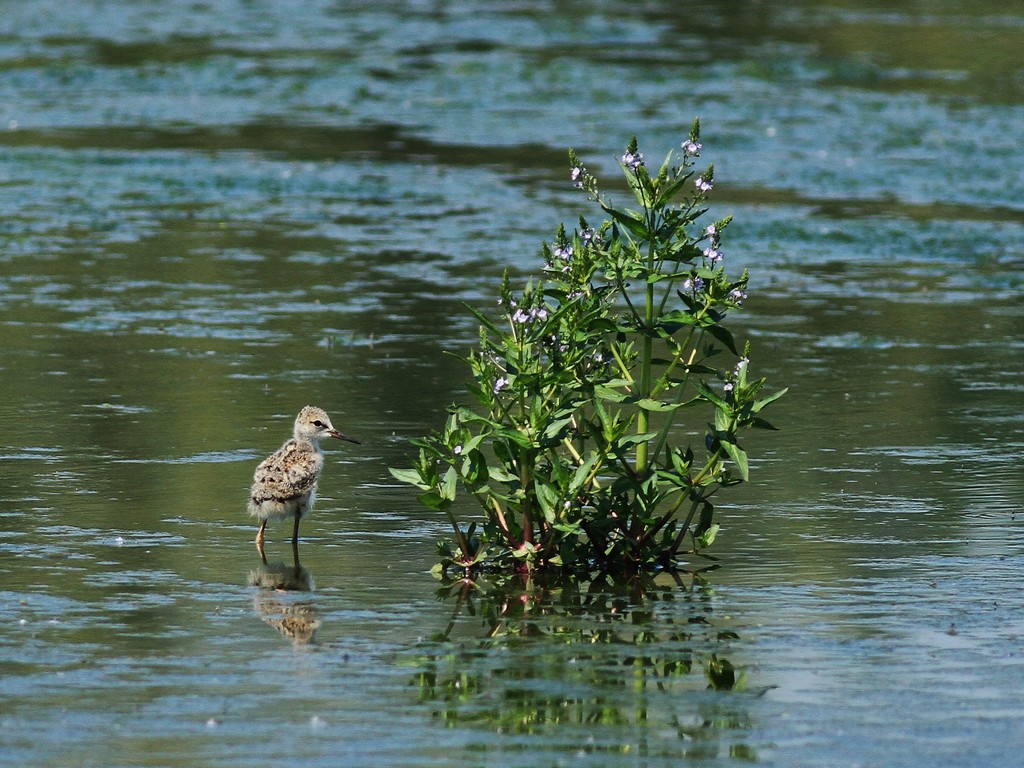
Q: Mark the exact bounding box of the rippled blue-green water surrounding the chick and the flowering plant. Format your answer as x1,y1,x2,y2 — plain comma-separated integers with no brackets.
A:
0,0,1024,767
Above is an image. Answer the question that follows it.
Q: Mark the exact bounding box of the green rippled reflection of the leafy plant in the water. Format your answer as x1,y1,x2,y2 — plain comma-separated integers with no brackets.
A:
414,573,764,759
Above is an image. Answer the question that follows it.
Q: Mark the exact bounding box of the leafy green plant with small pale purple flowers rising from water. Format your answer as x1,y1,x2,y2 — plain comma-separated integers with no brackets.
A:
391,121,785,571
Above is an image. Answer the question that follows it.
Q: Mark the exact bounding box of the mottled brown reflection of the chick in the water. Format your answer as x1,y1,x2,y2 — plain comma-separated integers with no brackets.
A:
249,562,321,645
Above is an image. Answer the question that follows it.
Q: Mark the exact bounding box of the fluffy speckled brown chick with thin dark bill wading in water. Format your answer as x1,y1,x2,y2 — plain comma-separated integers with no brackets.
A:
249,406,358,556
